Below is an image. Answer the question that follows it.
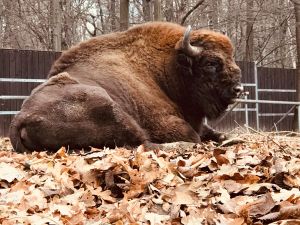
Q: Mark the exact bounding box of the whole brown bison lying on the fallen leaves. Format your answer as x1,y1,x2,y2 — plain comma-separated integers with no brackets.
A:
10,23,242,152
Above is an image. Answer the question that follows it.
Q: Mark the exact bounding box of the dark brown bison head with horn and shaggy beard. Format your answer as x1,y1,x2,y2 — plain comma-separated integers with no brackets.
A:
176,26,243,119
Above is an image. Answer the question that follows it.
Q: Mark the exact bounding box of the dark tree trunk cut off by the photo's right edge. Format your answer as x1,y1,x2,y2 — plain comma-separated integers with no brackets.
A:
292,0,300,132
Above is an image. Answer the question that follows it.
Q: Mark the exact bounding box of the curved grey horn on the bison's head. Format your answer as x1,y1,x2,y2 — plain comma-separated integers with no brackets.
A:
175,25,202,57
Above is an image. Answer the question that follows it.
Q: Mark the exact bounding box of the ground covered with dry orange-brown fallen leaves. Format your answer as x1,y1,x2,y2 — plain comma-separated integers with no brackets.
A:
0,133,300,225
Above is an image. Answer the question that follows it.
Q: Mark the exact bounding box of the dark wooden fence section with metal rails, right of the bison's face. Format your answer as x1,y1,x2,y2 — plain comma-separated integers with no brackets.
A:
216,62,297,131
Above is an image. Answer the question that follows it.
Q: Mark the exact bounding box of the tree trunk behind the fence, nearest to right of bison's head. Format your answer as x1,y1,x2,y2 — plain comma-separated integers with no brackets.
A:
244,0,254,62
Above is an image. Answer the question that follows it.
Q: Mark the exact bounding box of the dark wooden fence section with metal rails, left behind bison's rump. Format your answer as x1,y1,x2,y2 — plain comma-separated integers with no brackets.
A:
0,49,60,136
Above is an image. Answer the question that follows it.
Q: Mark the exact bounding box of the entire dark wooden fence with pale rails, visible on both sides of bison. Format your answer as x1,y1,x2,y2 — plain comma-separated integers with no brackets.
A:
0,49,296,136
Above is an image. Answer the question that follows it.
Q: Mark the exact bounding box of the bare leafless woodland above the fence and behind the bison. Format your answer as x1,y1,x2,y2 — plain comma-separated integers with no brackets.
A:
0,0,297,68
